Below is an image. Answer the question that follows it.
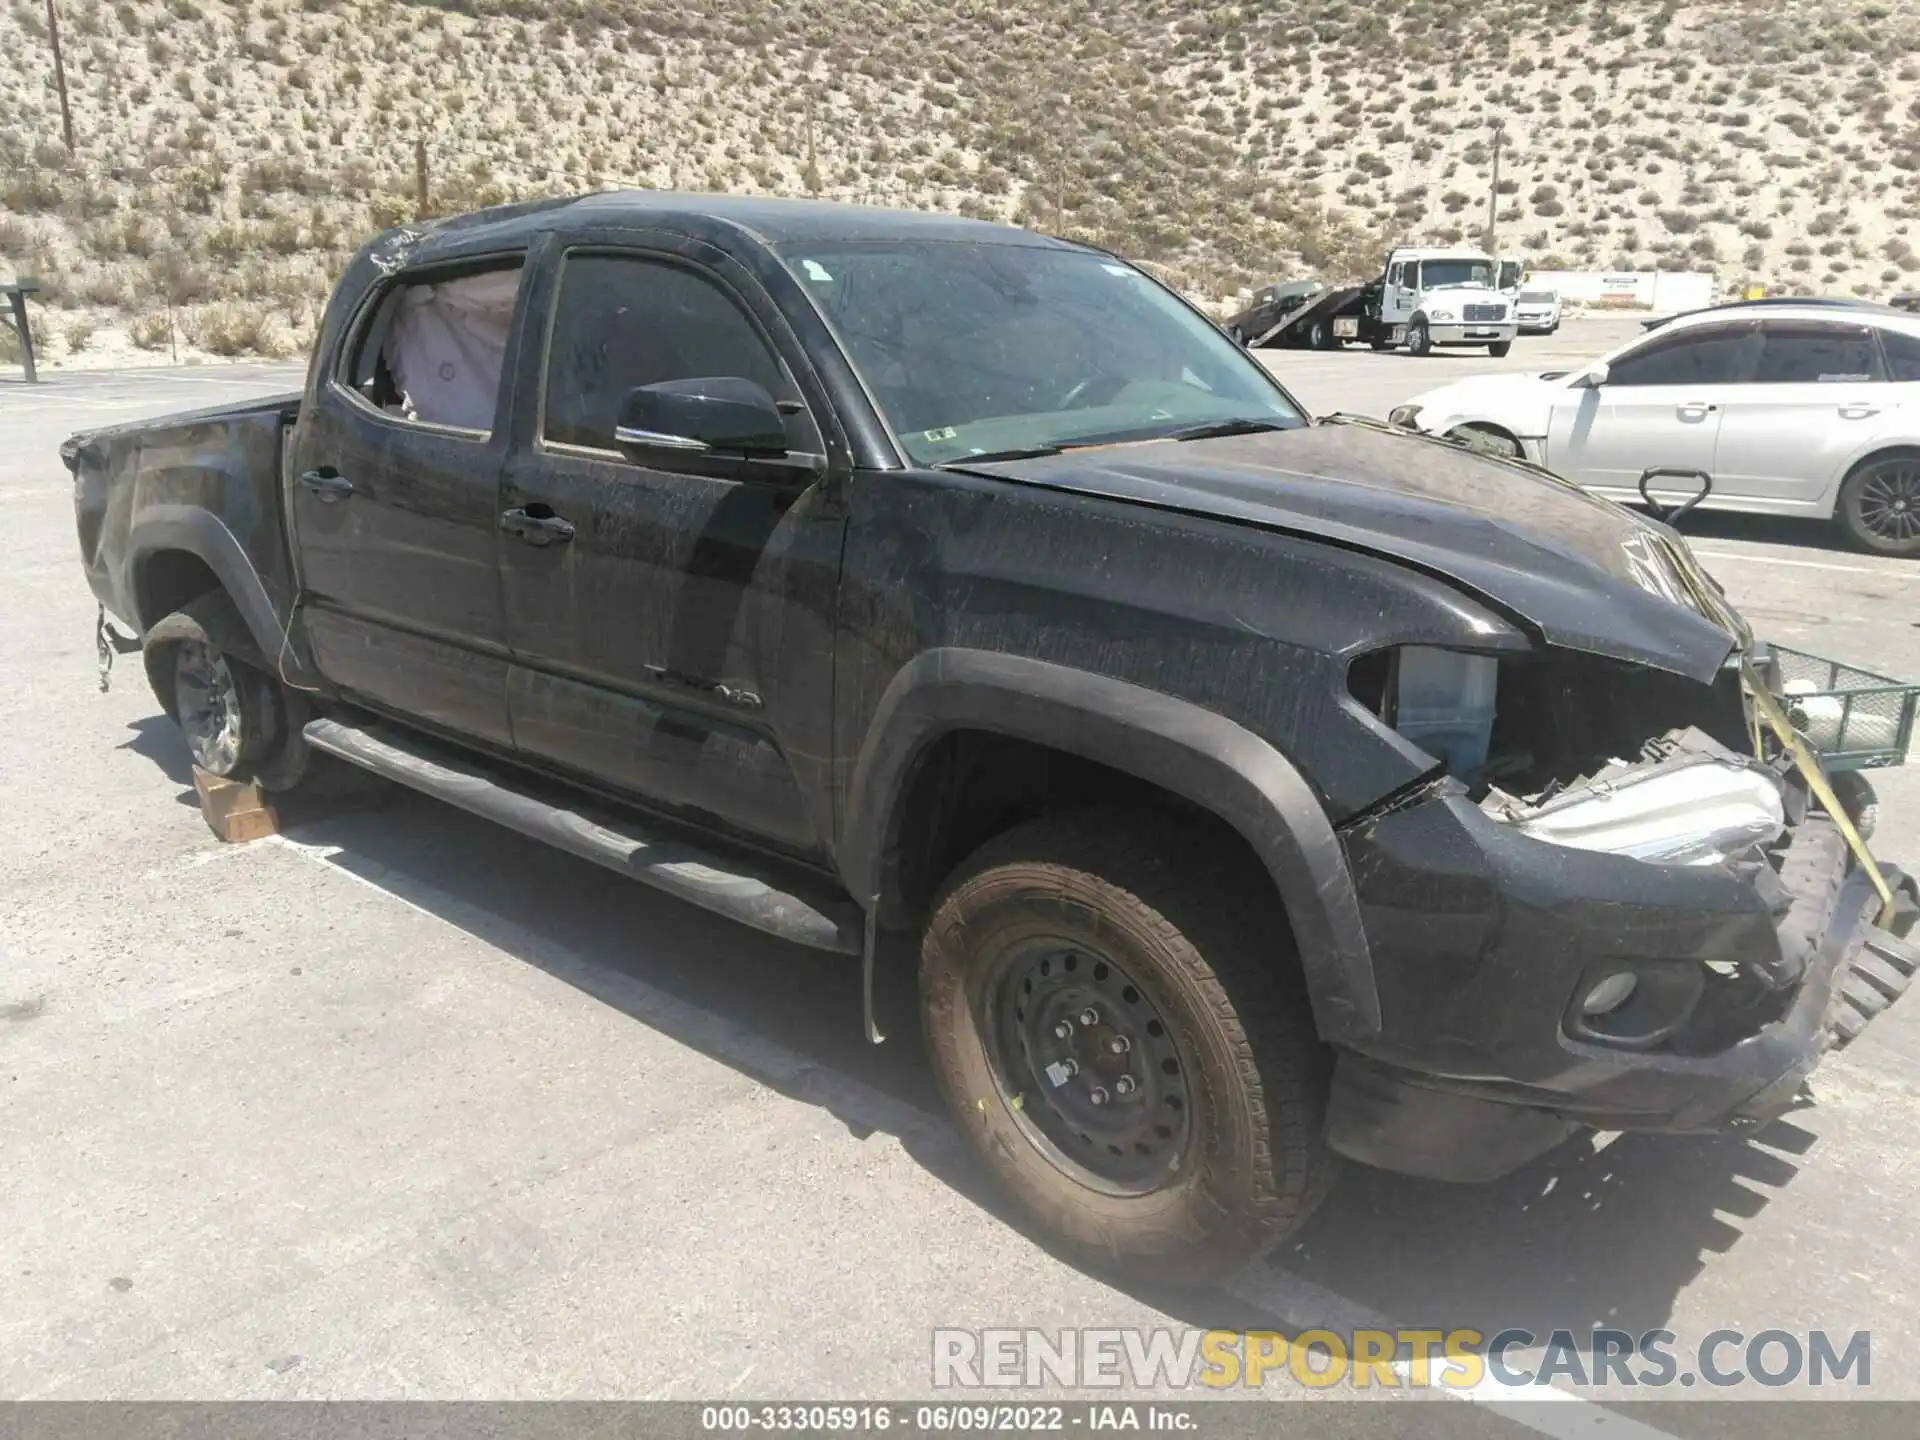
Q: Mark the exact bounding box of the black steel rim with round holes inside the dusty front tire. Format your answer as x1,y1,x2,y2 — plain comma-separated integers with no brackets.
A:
985,937,1196,1196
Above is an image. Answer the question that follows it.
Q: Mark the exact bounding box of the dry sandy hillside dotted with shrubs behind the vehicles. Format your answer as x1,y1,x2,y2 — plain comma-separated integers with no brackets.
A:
0,0,1920,361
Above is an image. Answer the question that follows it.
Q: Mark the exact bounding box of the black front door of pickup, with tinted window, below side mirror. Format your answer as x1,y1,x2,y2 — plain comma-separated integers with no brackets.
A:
499,240,845,856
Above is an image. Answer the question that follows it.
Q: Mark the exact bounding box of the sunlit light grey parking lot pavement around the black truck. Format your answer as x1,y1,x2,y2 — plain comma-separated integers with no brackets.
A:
0,336,1920,1434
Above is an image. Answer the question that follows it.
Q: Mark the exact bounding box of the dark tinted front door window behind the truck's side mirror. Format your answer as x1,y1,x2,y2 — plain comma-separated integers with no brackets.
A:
543,253,793,449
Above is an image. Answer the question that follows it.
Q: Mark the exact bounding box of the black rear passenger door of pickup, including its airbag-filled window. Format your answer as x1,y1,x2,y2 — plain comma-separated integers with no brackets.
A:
288,255,524,747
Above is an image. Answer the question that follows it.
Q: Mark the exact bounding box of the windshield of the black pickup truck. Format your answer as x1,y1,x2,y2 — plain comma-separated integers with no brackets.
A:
783,240,1306,465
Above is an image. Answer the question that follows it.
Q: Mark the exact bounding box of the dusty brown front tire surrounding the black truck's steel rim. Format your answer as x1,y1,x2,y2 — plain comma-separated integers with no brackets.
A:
920,810,1336,1284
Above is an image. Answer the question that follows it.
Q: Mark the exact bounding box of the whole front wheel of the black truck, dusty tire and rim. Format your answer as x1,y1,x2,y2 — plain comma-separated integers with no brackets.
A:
920,810,1334,1284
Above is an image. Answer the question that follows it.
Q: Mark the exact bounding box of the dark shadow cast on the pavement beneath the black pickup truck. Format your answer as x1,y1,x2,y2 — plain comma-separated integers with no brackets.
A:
255,770,1814,1334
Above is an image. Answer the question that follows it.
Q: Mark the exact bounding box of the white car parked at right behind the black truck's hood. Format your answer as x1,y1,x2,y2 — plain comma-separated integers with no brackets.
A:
1392,301,1920,557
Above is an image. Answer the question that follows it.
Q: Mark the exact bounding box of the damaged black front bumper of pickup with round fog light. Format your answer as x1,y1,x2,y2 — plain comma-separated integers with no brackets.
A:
1327,737,1920,1181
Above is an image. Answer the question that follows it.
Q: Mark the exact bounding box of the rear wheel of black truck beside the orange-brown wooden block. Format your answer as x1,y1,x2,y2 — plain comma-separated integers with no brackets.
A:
140,589,311,791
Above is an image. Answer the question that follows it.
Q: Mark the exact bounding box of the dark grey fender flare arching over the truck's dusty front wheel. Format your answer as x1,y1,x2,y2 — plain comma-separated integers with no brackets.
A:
839,647,1380,1043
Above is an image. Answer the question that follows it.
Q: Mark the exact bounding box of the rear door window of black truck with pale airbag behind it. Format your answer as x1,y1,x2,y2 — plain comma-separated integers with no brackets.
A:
346,261,522,434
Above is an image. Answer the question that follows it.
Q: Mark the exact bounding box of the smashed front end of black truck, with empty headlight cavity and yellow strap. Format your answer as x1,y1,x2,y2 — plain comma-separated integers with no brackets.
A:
1329,532,1920,1181
